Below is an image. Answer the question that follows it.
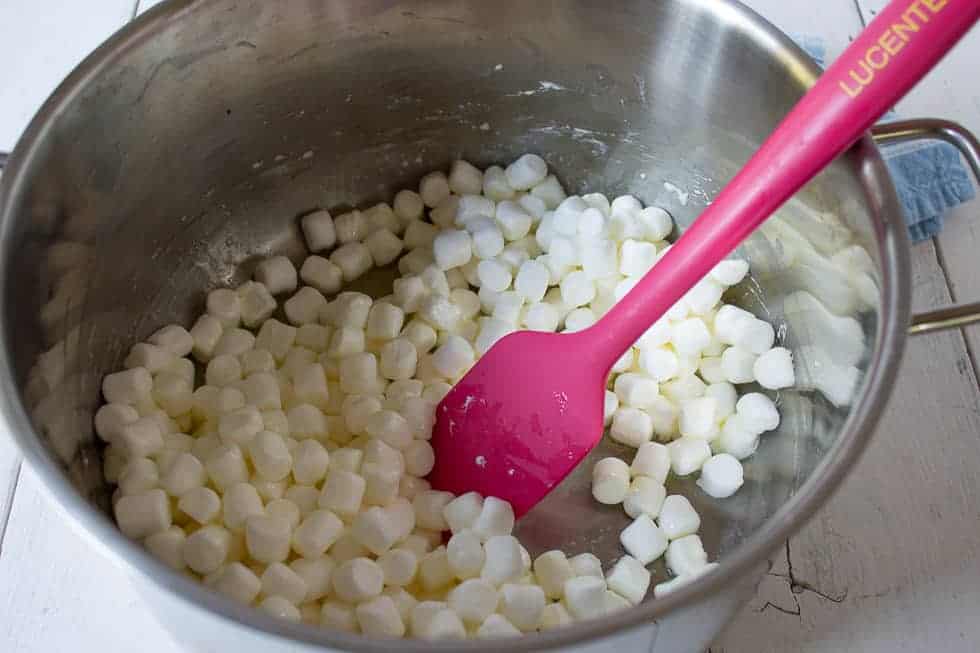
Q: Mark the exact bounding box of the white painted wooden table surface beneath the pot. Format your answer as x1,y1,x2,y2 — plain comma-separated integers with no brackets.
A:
0,0,980,653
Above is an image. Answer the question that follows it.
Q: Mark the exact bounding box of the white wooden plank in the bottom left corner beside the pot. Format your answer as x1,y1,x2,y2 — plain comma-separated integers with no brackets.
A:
0,467,180,653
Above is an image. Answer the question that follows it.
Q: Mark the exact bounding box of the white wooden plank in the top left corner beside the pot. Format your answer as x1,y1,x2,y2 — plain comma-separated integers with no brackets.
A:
0,0,136,151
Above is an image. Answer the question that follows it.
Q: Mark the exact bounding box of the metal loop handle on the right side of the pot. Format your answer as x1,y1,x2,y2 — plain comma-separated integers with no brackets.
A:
871,118,980,335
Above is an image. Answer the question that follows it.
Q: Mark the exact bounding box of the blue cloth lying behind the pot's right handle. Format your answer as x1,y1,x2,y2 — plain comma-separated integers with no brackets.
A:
793,35,976,241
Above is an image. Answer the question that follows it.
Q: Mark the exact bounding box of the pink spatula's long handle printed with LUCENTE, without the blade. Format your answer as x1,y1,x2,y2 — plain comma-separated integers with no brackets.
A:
581,0,980,368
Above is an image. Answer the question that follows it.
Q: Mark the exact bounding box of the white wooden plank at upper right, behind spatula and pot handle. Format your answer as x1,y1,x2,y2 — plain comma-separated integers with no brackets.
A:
857,0,980,371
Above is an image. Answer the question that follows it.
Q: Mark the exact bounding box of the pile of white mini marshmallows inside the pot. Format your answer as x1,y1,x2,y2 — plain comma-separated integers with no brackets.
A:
95,154,793,639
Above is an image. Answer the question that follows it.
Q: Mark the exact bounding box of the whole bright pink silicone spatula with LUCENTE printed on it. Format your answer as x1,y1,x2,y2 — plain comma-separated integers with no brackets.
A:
429,0,980,516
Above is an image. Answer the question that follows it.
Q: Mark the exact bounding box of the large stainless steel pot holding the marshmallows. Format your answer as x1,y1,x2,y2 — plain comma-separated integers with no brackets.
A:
0,0,980,651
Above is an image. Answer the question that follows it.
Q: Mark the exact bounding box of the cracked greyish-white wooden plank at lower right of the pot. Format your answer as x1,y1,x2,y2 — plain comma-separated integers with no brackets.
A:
711,238,980,653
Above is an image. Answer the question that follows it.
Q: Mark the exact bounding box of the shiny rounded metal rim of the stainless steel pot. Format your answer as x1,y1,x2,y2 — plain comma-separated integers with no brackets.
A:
0,0,910,653
